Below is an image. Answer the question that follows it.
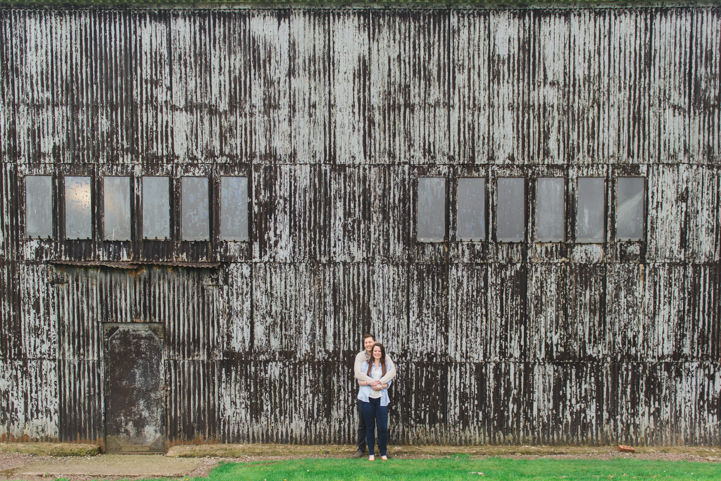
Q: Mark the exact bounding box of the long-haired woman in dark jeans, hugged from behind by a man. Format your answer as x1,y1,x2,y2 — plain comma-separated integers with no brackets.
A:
358,343,390,461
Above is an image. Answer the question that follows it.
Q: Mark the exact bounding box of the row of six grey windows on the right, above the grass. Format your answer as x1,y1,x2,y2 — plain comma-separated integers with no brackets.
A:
416,177,646,243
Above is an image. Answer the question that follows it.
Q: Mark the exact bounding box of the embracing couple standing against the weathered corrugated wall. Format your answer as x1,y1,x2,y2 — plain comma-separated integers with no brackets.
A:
353,334,396,461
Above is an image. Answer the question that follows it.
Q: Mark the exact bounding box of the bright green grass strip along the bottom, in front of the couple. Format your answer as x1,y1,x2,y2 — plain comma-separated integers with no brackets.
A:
195,456,721,481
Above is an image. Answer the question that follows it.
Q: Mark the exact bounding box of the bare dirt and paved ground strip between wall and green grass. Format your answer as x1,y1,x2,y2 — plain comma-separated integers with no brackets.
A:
0,443,721,481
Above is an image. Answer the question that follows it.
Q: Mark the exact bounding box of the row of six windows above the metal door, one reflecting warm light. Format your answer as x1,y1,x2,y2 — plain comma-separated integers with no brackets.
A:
25,176,248,241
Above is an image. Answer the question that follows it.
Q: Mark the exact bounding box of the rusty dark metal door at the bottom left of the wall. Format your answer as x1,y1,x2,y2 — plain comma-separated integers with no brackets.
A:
105,324,165,453
